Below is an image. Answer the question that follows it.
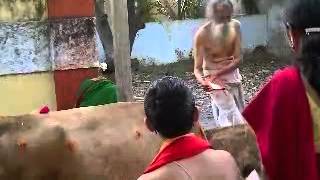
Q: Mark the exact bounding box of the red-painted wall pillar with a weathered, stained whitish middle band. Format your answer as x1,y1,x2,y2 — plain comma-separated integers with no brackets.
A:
48,0,98,110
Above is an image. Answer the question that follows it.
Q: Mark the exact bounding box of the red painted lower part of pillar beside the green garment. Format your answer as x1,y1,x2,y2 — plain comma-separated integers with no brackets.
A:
54,68,98,110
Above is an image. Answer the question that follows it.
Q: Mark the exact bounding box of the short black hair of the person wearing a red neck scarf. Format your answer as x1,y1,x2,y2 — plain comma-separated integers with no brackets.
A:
144,77,195,138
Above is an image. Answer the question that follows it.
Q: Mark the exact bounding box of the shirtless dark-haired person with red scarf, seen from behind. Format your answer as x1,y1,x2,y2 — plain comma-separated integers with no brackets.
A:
138,77,241,180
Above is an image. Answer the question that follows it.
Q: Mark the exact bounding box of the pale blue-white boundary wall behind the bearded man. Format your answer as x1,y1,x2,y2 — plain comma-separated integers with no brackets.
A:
127,15,268,64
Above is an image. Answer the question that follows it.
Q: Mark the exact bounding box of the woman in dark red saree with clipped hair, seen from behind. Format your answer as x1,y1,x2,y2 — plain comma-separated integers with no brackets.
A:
243,0,320,180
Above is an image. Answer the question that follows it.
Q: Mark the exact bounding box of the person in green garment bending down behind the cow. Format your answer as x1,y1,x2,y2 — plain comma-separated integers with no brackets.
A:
75,63,118,108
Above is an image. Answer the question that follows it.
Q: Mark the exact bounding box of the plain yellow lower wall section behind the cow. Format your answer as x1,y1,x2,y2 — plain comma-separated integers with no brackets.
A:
0,72,56,116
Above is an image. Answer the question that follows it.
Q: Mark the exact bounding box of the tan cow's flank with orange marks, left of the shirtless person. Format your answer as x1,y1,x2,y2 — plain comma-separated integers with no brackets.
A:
0,103,262,180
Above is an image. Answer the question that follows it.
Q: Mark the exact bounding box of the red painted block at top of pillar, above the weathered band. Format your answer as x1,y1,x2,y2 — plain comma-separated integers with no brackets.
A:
48,0,95,18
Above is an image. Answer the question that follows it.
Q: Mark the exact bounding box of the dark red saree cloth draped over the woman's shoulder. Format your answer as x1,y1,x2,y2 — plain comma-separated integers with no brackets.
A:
243,67,320,180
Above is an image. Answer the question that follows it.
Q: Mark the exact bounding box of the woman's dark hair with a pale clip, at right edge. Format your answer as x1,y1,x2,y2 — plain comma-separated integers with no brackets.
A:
285,0,320,95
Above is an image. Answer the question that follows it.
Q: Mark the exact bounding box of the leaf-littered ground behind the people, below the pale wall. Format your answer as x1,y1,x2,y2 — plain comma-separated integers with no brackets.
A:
133,47,289,129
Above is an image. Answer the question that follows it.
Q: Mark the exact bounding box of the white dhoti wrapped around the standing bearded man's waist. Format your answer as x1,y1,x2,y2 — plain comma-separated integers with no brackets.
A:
204,69,245,128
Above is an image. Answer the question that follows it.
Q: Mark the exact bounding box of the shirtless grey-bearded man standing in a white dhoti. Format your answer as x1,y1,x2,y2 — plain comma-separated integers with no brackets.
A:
194,0,244,126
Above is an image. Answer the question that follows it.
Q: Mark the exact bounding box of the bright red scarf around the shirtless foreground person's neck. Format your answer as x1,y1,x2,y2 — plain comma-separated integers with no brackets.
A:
144,134,211,174
